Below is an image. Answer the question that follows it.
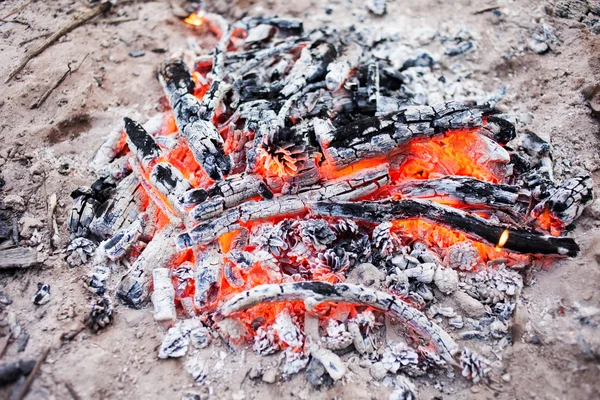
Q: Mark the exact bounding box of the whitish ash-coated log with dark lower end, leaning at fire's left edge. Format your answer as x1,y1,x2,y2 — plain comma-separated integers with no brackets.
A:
116,225,178,308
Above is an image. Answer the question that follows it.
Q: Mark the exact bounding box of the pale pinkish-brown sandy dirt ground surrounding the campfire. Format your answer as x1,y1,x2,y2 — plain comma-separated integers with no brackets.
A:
0,0,600,399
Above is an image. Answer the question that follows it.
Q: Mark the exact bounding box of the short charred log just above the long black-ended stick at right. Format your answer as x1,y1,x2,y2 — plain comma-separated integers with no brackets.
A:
390,176,531,214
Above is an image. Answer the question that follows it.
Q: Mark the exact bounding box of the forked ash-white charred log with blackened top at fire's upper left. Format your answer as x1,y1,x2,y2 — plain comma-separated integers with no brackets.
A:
159,59,231,181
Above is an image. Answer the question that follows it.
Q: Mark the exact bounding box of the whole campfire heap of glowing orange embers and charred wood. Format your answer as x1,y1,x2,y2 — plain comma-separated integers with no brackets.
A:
68,9,592,393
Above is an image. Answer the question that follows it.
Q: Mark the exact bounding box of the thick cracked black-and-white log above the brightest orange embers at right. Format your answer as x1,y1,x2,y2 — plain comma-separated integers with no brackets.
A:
317,102,506,169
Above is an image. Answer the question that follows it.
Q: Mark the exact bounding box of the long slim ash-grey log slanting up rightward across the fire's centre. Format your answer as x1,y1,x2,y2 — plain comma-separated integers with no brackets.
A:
177,165,389,248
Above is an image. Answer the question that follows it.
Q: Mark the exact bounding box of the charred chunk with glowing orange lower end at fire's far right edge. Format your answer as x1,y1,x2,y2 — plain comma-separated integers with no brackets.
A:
531,175,594,233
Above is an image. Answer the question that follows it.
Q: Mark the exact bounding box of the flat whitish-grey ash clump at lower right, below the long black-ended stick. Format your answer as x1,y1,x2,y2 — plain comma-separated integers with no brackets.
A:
459,265,523,304
